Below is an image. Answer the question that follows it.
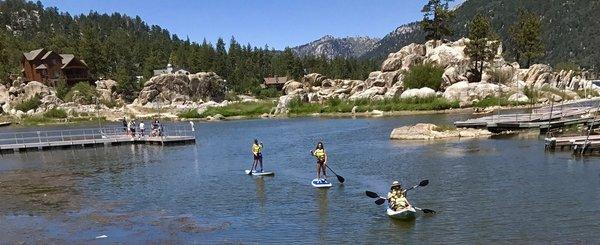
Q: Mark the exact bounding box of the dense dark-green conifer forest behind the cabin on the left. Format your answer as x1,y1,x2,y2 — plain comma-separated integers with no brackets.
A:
0,0,379,97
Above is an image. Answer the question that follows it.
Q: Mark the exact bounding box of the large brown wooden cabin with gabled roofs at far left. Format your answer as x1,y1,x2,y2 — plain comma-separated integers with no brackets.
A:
21,49,92,86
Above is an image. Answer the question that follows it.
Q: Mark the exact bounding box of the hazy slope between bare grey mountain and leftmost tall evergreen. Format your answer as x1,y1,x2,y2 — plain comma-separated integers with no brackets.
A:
360,22,425,61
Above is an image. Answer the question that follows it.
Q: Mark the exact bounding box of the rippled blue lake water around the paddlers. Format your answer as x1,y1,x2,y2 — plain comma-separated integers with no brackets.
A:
0,115,600,244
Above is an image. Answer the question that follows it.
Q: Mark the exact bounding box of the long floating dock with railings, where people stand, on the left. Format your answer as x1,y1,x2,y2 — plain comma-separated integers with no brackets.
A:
0,126,196,153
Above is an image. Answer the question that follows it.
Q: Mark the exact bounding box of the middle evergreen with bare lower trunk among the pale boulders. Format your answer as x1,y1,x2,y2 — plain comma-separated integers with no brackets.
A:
465,14,500,82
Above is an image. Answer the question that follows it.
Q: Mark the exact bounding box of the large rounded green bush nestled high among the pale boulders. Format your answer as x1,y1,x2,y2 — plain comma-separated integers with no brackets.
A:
404,63,444,91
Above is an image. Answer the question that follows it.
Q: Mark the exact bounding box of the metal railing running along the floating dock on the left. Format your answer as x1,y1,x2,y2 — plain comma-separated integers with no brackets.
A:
0,125,194,146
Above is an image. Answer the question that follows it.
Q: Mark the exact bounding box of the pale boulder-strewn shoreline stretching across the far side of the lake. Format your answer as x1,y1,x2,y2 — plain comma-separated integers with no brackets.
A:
0,38,600,126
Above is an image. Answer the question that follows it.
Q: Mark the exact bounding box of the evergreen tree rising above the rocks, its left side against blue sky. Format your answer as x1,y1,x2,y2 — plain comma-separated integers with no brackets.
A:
421,0,454,40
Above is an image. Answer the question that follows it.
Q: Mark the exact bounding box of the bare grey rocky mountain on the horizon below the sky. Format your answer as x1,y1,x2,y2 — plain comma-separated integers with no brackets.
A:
292,35,379,59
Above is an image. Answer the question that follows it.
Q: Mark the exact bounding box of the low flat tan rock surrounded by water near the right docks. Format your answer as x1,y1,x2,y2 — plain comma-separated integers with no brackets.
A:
390,123,492,140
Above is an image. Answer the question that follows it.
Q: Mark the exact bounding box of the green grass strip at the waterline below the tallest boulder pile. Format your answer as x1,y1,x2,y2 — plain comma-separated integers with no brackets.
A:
288,97,458,115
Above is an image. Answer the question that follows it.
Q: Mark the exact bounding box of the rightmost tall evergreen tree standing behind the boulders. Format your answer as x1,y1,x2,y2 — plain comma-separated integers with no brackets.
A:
509,10,545,68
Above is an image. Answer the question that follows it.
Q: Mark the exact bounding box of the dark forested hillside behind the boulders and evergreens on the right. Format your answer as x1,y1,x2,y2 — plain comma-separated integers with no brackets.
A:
361,0,600,68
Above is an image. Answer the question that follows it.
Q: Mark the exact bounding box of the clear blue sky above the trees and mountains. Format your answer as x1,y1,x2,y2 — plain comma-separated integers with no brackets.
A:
42,0,436,49
